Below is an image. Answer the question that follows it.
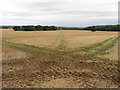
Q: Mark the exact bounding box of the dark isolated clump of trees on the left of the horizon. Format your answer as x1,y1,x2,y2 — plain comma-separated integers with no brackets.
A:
13,25,57,31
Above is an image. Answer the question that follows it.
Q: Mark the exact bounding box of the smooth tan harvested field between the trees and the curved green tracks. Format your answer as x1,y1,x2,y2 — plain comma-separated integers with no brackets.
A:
3,29,118,48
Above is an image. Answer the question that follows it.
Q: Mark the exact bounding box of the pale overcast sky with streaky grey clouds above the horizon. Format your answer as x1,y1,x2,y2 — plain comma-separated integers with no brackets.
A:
0,0,119,27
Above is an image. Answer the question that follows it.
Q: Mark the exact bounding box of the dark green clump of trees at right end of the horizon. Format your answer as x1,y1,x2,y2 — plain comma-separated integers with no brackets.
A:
83,25,120,31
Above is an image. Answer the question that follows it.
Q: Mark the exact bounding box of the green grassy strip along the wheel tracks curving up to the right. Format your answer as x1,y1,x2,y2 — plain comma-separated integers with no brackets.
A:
74,38,117,56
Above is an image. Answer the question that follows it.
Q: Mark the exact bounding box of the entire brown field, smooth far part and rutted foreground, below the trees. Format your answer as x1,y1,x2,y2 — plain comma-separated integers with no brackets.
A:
2,29,120,88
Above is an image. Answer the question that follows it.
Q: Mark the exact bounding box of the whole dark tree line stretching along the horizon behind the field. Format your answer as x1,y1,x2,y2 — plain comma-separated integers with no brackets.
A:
0,25,120,31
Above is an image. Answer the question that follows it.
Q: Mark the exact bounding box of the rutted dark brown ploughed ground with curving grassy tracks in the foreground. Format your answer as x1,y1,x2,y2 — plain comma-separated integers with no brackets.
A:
2,37,120,88
